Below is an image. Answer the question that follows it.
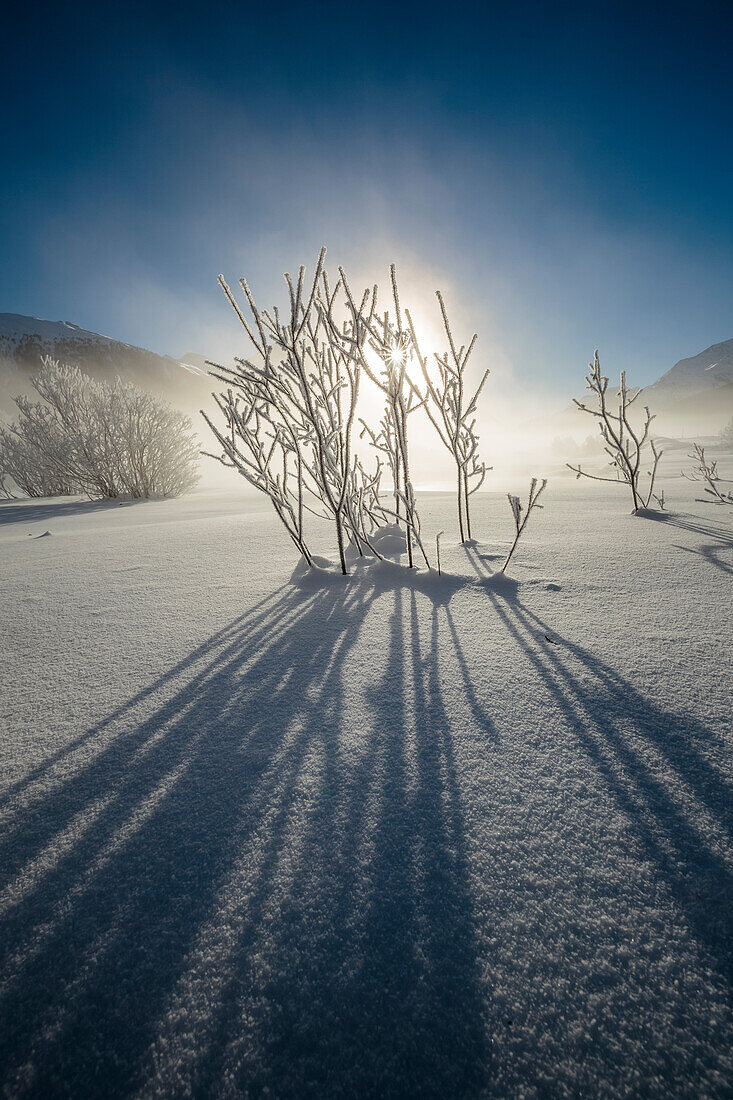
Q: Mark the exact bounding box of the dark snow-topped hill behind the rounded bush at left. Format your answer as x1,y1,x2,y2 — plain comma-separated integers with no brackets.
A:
0,314,211,411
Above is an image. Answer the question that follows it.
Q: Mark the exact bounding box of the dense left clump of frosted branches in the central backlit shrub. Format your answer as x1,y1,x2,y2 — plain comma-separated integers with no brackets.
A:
201,249,387,573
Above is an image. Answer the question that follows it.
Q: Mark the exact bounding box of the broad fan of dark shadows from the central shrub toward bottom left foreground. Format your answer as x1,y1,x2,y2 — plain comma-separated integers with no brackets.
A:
0,576,489,1097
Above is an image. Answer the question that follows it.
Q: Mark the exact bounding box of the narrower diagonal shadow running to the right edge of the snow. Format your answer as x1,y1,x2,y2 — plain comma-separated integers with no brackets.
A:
467,550,733,989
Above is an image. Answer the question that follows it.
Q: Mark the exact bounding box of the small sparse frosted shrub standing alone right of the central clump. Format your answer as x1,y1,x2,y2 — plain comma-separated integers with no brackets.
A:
567,349,663,512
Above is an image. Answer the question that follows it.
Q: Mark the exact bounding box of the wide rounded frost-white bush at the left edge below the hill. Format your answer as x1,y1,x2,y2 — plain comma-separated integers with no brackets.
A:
0,358,198,498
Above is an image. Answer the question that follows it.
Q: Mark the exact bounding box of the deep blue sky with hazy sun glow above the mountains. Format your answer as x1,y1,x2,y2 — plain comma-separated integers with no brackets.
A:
0,2,733,392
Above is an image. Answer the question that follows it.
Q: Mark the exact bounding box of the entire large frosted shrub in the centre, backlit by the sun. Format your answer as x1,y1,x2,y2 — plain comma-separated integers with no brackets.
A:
201,249,488,573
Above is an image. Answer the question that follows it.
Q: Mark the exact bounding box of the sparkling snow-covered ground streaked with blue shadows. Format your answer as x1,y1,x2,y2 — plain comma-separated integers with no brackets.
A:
0,482,733,1098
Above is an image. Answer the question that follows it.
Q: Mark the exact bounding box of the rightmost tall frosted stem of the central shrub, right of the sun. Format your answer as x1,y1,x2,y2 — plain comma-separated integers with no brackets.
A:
405,290,490,542
